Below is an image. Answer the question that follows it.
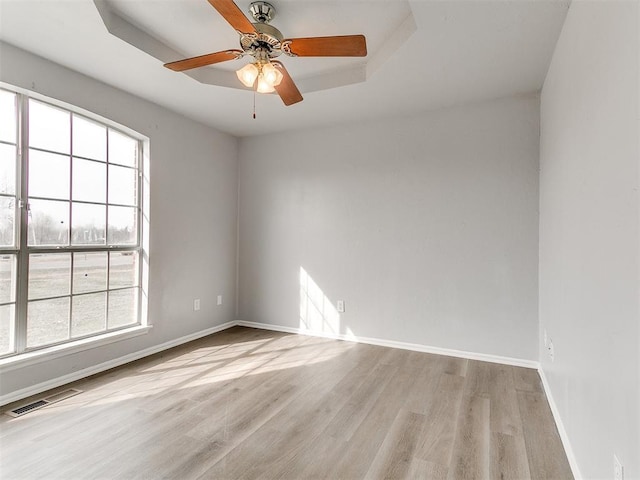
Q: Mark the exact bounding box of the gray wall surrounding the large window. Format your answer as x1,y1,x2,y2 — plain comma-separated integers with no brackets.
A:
0,44,237,394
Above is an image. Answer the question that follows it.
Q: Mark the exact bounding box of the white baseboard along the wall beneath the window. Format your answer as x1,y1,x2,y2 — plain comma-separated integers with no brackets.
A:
0,322,236,405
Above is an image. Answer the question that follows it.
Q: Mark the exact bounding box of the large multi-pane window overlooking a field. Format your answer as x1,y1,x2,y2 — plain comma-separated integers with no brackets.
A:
0,85,144,356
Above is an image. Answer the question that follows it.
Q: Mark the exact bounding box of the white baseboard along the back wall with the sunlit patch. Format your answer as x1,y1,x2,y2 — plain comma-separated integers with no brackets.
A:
236,320,540,370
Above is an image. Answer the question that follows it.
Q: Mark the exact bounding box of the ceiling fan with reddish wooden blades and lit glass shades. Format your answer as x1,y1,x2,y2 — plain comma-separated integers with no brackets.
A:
164,0,367,105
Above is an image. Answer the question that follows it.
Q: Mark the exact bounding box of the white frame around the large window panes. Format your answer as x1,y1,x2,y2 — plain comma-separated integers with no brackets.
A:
0,82,152,374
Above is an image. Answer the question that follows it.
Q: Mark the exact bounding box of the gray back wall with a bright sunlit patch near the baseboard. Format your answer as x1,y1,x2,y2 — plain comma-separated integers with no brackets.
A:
238,97,539,360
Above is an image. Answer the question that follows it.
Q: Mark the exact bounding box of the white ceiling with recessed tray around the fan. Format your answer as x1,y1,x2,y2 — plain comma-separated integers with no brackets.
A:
0,0,569,136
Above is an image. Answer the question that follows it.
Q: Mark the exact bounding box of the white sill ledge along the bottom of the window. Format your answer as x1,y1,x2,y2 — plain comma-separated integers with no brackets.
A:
0,325,152,374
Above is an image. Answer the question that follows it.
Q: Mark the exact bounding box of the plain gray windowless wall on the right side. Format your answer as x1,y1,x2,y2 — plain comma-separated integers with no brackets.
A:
540,1,640,479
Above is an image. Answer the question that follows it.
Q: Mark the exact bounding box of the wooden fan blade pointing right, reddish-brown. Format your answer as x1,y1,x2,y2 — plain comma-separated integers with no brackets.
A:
282,35,367,57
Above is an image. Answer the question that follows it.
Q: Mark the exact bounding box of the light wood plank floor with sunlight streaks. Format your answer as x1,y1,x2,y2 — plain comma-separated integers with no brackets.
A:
0,327,572,480
